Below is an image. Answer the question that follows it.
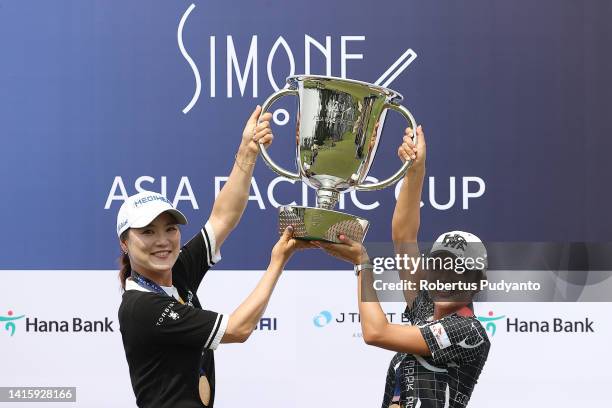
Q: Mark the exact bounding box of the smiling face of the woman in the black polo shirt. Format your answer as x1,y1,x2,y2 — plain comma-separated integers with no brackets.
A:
121,212,181,284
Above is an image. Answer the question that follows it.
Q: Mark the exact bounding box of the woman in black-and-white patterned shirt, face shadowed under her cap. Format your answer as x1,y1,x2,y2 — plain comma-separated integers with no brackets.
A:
315,126,490,408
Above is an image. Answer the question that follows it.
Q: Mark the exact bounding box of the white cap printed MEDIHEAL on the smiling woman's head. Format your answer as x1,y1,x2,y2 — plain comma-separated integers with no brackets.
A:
117,191,187,237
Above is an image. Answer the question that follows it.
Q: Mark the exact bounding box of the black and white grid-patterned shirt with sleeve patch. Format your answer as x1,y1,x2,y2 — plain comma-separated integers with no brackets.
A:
382,291,491,408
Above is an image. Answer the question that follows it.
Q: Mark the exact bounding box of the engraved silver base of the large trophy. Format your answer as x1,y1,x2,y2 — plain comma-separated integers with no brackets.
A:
278,205,370,243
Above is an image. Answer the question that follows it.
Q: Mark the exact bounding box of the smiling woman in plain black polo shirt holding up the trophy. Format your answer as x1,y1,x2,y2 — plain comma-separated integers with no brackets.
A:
117,106,307,408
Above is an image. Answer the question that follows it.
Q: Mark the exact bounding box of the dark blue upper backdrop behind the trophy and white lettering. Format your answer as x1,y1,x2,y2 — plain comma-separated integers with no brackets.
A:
0,0,612,269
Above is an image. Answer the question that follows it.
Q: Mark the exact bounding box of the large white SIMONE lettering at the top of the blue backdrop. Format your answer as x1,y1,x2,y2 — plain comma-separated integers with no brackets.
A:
177,4,417,108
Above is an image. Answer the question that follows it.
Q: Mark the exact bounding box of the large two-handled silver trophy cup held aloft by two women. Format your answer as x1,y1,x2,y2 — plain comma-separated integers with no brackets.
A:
259,75,416,242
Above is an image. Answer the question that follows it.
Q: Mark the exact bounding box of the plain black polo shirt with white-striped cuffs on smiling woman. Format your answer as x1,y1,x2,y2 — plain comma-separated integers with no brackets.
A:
119,223,229,408
